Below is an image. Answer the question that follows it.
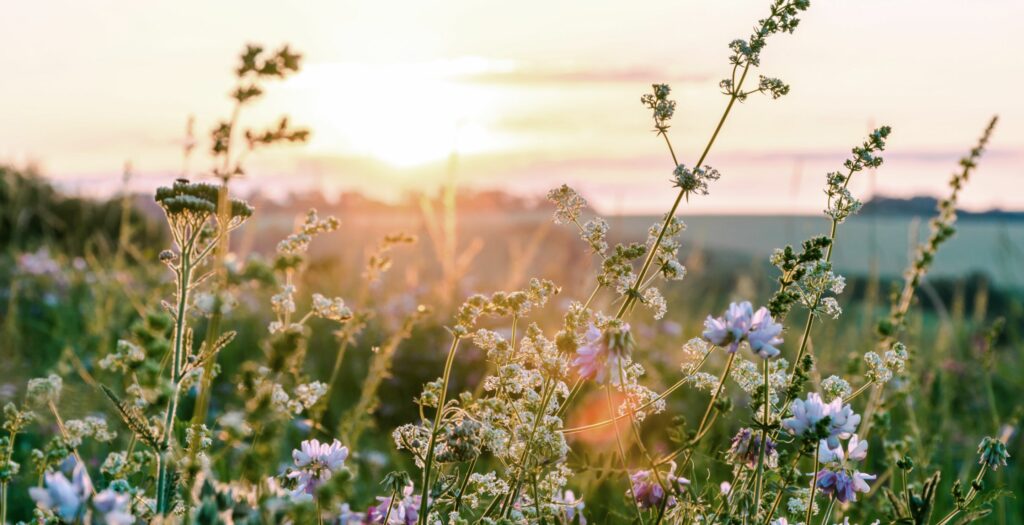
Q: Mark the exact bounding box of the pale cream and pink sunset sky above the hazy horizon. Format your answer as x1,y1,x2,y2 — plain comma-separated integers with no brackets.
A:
0,0,1024,214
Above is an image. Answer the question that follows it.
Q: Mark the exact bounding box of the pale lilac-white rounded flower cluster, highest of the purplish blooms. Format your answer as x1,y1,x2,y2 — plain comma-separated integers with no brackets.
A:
703,301,782,359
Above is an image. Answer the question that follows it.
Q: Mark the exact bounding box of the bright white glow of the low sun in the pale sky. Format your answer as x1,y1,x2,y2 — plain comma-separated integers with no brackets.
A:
288,59,505,168
